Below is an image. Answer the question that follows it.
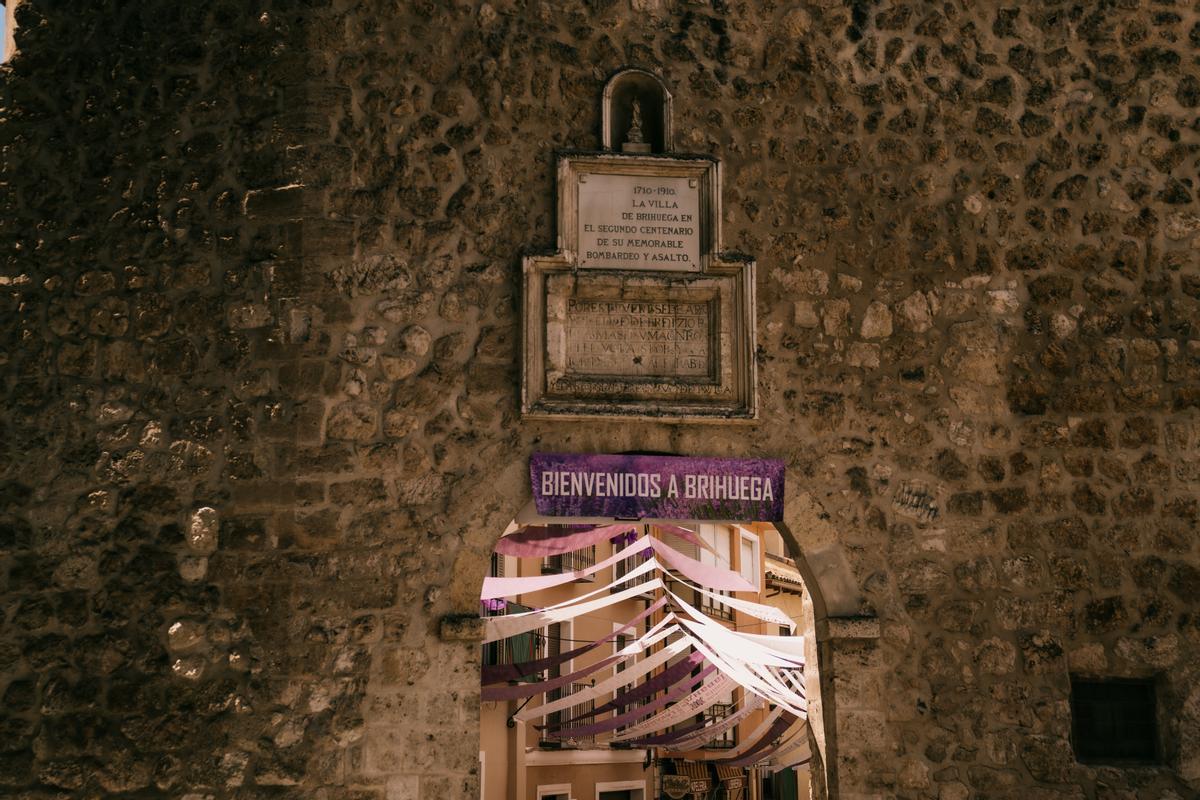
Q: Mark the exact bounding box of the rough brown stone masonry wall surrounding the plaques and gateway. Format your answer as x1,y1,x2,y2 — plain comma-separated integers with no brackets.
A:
0,0,1200,800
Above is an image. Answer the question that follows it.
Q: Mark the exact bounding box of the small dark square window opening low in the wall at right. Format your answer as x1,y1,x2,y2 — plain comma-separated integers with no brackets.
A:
1070,678,1159,764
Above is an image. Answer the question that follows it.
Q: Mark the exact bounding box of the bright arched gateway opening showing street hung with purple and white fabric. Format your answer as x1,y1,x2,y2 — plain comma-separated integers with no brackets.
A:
453,455,858,800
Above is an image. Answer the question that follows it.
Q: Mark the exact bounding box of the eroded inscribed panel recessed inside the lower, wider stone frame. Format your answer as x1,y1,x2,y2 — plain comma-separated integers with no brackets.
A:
564,297,712,378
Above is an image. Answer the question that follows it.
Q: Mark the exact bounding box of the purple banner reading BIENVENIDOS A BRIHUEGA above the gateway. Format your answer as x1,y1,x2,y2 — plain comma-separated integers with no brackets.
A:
529,453,784,522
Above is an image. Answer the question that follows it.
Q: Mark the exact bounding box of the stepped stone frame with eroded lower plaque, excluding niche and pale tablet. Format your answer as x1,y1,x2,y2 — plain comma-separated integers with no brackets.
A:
521,152,758,422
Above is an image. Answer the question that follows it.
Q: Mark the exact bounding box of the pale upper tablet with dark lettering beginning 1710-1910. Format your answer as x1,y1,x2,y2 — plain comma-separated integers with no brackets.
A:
578,174,700,271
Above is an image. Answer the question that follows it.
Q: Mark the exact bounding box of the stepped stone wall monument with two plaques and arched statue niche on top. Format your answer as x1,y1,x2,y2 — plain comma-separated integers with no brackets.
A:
521,71,757,421
